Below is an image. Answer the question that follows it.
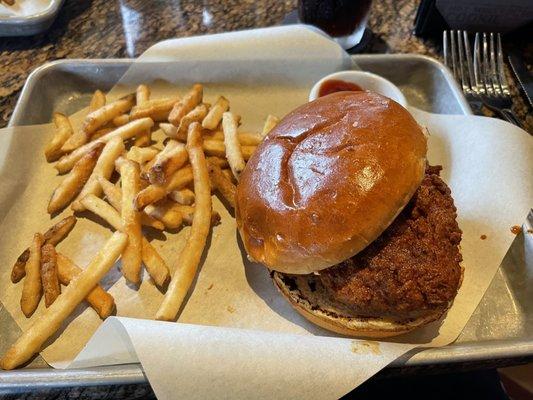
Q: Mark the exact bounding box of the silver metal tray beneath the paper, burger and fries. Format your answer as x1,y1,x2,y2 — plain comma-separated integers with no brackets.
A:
0,55,533,394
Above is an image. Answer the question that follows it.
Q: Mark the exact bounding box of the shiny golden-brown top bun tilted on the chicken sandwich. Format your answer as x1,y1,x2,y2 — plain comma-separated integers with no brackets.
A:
236,91,427,274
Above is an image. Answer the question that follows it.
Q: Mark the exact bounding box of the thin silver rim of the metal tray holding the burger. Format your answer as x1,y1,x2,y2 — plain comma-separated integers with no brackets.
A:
0,54,533,390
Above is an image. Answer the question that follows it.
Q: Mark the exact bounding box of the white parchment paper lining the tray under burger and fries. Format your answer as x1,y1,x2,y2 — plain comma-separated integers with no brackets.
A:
0,27,533,399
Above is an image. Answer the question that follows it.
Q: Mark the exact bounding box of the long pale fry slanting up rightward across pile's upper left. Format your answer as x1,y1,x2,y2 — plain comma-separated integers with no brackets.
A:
55,118,154,174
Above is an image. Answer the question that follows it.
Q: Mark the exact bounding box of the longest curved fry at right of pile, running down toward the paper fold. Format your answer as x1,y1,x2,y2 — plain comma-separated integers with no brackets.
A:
156,122,211,321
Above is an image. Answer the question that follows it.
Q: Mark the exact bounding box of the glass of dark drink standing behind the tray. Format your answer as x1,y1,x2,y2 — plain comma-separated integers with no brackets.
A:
298,0,372,49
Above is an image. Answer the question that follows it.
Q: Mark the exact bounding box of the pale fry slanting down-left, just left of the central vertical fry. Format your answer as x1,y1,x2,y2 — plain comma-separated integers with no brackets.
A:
71,136,124,211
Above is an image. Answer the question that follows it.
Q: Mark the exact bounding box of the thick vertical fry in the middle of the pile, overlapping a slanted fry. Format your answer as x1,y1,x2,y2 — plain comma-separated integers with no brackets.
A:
120,160,142,285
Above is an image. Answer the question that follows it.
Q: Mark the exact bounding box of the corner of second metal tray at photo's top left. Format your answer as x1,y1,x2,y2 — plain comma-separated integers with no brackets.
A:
0,0,64,37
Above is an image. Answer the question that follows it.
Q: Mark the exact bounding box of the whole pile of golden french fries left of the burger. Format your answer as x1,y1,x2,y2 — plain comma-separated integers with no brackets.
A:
0,84,278,369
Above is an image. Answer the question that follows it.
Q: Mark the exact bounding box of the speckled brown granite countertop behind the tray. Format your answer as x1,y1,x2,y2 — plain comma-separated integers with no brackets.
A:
0,0,533,132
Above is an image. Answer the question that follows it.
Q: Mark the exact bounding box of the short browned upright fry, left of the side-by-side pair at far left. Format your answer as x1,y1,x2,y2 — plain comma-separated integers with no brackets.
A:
20,233,44,318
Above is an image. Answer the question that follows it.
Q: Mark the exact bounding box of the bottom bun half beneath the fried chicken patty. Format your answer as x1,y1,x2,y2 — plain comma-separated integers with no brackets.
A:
271,268,463,338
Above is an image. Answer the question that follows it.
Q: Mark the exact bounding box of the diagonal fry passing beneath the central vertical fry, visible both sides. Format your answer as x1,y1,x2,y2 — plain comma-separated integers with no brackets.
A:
82,195,170,286
